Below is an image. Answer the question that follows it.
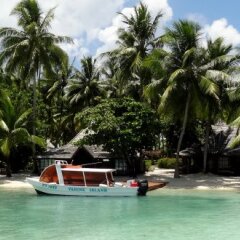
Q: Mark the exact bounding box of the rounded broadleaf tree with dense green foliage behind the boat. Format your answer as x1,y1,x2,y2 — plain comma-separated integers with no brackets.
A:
76,98,159,175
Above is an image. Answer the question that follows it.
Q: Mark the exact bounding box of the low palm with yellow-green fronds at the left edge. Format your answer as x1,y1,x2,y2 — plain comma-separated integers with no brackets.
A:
0,91,45,177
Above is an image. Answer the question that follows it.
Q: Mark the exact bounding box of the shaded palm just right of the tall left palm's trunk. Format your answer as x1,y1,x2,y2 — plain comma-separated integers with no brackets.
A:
41,56,77,144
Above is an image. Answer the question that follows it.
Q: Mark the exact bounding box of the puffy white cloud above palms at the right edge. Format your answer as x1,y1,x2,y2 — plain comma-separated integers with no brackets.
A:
203,18,240,46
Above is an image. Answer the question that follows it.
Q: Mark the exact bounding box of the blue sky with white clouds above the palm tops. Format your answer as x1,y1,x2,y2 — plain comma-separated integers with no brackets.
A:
0,0,240,61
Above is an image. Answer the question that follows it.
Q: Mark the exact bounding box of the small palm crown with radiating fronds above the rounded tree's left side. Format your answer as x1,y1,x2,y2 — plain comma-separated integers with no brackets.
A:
64,57,105,110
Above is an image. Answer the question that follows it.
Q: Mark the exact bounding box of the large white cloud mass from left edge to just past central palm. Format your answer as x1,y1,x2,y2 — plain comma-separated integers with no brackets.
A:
0,0,172,59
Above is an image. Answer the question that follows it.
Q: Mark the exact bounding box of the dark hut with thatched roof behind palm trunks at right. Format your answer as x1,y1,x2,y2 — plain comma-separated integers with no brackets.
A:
179,122,240,175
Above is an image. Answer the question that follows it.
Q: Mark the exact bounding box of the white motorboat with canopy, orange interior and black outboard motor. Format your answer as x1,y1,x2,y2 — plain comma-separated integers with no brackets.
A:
27,160,148,196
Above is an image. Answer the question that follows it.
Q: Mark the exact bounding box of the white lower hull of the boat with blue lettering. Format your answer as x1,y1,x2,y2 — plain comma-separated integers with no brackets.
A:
27,178,138,197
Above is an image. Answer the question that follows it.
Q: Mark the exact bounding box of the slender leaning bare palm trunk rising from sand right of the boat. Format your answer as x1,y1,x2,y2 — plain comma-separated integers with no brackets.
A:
174,91,191,178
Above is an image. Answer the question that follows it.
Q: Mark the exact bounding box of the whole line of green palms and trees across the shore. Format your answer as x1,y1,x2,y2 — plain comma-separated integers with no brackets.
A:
0,0,240,177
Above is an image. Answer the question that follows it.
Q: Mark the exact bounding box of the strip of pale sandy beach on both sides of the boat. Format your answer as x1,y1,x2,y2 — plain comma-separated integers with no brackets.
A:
0,169,240,190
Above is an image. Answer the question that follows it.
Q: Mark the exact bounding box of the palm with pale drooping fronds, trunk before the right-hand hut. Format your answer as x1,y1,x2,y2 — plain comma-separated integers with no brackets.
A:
201,38,239,173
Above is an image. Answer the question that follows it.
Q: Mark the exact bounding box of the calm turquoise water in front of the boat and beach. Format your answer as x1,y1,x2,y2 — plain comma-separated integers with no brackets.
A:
0,188,240,240
